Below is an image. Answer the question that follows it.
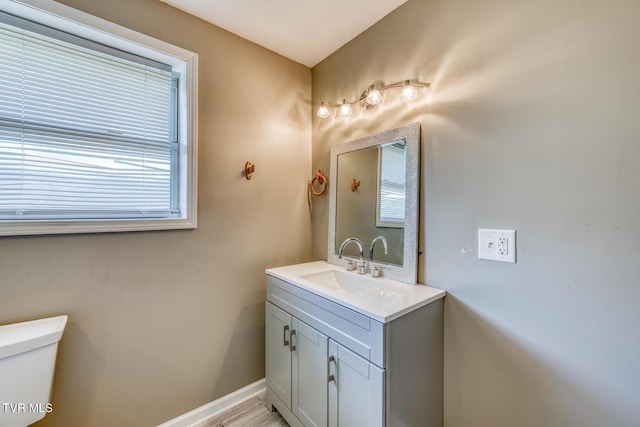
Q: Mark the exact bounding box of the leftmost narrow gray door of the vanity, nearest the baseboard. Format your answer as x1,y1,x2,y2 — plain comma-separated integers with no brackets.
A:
265,302,291,409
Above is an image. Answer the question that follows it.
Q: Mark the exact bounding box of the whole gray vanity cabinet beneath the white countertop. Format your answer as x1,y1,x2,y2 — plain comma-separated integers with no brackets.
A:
265,275,443,427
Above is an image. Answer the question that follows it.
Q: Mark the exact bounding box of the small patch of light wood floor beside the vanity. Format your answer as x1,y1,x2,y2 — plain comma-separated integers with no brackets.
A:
192,392,289,427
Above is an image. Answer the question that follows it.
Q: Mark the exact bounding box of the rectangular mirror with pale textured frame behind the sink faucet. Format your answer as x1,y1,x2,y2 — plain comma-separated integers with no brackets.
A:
327,123,420,284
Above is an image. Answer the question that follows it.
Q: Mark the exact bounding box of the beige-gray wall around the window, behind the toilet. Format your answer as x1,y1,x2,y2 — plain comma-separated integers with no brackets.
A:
0,0,311,427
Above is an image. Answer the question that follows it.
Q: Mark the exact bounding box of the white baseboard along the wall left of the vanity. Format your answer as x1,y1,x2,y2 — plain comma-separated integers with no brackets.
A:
158,378,266,427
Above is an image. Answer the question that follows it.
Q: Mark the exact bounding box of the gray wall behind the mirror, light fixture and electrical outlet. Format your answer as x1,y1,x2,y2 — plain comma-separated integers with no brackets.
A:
312,0,640,427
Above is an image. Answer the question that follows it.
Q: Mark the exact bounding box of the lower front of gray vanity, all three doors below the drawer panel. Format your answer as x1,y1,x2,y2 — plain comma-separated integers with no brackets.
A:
266,302,384,427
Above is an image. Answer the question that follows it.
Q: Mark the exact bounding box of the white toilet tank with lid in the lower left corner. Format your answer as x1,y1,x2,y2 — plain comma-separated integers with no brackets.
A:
0,316,67,427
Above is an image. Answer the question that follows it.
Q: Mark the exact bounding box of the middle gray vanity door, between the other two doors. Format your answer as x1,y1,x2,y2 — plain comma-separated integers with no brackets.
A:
291,317,329,427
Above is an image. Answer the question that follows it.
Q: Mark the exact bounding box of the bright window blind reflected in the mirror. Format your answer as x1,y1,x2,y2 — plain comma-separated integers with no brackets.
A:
377,141,407,226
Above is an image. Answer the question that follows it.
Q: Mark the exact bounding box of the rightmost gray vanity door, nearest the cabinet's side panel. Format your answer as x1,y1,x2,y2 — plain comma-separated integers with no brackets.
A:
329,340,384,427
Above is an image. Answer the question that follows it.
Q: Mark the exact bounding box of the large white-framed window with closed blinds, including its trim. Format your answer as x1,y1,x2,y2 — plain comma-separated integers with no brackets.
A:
0,0,197,235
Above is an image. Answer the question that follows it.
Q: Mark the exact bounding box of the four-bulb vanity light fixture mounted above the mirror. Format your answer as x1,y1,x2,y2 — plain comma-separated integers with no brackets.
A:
316,80,430,119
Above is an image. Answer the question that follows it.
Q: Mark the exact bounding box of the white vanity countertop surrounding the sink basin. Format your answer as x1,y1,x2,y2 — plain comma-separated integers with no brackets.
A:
266,261,446,323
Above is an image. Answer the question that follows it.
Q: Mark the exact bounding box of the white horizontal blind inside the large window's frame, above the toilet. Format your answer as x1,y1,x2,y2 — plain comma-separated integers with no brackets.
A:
0,14,180,220
